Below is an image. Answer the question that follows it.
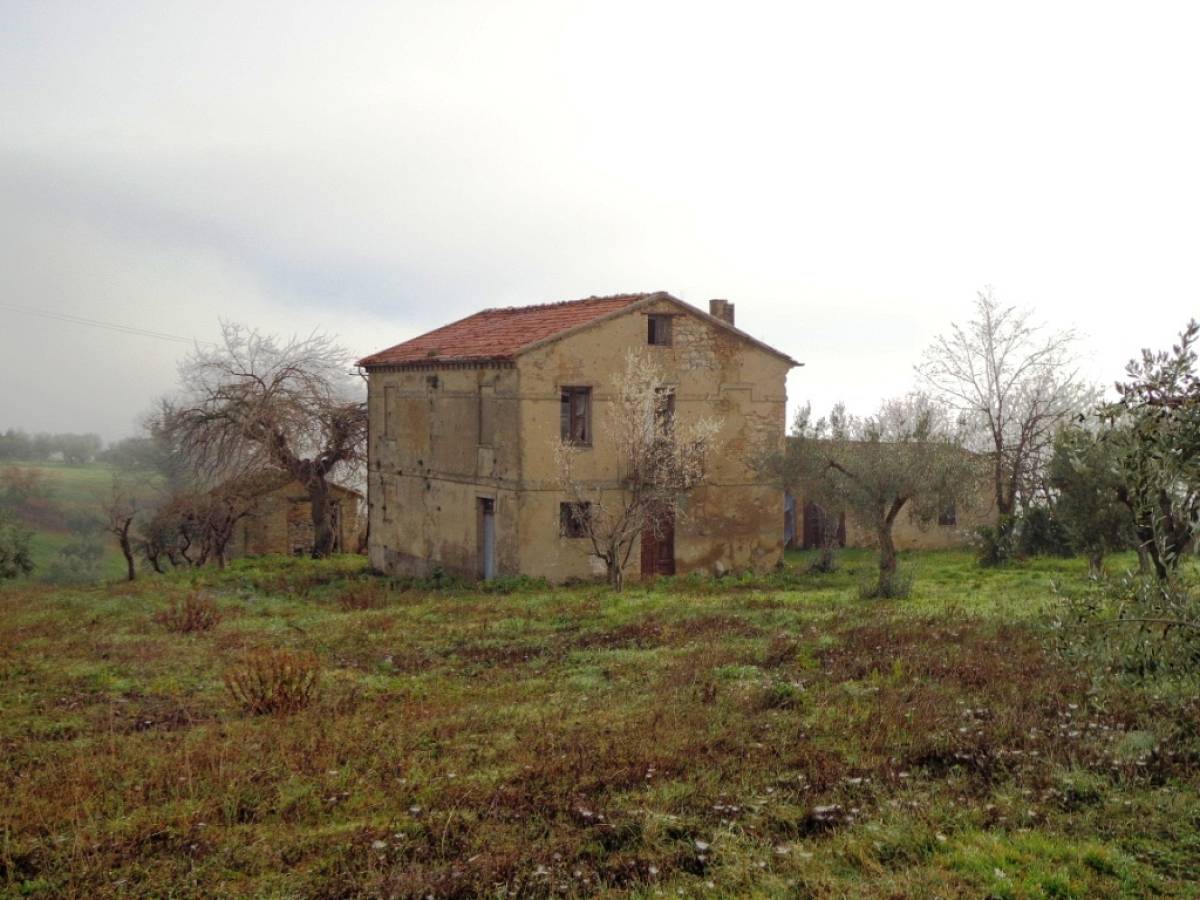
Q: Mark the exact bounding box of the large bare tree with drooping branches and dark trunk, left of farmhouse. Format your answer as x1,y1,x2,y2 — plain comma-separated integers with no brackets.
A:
157,323,367,560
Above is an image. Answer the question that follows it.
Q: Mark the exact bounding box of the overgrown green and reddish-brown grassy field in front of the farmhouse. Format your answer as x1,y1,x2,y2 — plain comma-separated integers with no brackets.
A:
0,553,1200,898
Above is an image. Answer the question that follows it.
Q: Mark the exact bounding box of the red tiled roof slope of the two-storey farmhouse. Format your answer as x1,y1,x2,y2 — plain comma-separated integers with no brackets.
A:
359,294,653,367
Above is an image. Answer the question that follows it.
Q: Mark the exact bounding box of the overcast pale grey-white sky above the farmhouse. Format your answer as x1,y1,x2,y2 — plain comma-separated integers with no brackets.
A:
0,0,1200,438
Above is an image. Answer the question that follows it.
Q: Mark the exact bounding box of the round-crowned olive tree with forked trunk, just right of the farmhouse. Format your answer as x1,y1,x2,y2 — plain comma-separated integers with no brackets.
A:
773,394,978,596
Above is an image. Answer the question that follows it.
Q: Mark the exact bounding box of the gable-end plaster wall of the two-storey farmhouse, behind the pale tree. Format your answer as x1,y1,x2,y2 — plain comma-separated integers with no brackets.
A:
517,302,788,577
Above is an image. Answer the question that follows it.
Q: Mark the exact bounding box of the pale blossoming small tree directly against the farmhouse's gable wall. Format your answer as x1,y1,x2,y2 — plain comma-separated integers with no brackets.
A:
556,350,720,590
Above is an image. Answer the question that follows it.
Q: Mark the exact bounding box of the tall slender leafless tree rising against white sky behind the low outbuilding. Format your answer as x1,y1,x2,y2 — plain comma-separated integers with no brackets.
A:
917,287,1096,517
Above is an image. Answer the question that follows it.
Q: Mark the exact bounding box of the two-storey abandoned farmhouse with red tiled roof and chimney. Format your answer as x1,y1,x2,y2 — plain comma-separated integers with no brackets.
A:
359,292,799,582
